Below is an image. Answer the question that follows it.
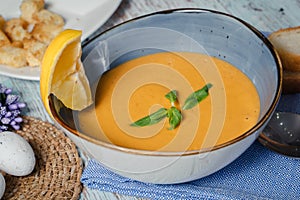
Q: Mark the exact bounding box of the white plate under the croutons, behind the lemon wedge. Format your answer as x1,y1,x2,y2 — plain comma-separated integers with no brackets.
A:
0,0,121,81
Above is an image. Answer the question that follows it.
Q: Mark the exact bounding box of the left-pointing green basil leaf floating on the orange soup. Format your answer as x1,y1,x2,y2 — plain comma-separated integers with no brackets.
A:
130,108,168,127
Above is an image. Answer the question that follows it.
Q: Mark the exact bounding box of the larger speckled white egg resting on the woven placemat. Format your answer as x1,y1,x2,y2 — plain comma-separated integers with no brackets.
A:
0,131,35,176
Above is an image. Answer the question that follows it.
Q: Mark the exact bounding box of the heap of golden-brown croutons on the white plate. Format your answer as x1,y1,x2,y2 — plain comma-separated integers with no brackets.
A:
0,0,64,67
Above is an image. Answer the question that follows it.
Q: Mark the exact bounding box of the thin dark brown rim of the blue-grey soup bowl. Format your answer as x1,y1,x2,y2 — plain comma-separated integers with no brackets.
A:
49,8,283,156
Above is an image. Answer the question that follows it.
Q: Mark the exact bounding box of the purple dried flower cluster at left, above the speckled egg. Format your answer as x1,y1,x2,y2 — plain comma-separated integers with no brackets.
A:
0,84,26,132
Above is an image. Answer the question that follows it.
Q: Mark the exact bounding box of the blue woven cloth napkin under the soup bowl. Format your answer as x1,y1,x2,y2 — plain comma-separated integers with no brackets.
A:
81,94,300,199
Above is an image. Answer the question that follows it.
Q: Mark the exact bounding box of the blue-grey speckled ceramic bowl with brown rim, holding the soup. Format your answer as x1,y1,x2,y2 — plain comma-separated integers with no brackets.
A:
51,9,282,184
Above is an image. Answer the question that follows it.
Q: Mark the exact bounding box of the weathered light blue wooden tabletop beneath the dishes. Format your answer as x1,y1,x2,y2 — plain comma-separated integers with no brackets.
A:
0,0,300,199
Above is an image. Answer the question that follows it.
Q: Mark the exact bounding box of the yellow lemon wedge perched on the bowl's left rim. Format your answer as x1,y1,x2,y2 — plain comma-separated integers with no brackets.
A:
40,29,93,116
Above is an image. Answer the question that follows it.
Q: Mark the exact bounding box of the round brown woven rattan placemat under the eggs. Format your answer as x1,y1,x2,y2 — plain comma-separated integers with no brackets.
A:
3,117,82,200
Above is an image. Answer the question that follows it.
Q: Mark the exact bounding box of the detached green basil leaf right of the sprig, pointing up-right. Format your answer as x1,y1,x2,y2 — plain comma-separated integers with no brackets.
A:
182,83,212,110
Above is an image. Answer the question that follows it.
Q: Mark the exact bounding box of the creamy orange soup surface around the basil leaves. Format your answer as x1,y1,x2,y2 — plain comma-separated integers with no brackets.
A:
78,52,260,152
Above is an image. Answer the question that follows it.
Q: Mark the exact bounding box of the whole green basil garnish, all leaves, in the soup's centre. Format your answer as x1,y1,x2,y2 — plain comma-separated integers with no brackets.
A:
130,83,212,130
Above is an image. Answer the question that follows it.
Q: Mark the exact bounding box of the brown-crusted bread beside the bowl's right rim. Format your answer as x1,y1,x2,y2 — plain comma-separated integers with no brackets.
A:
269,26,300,93
